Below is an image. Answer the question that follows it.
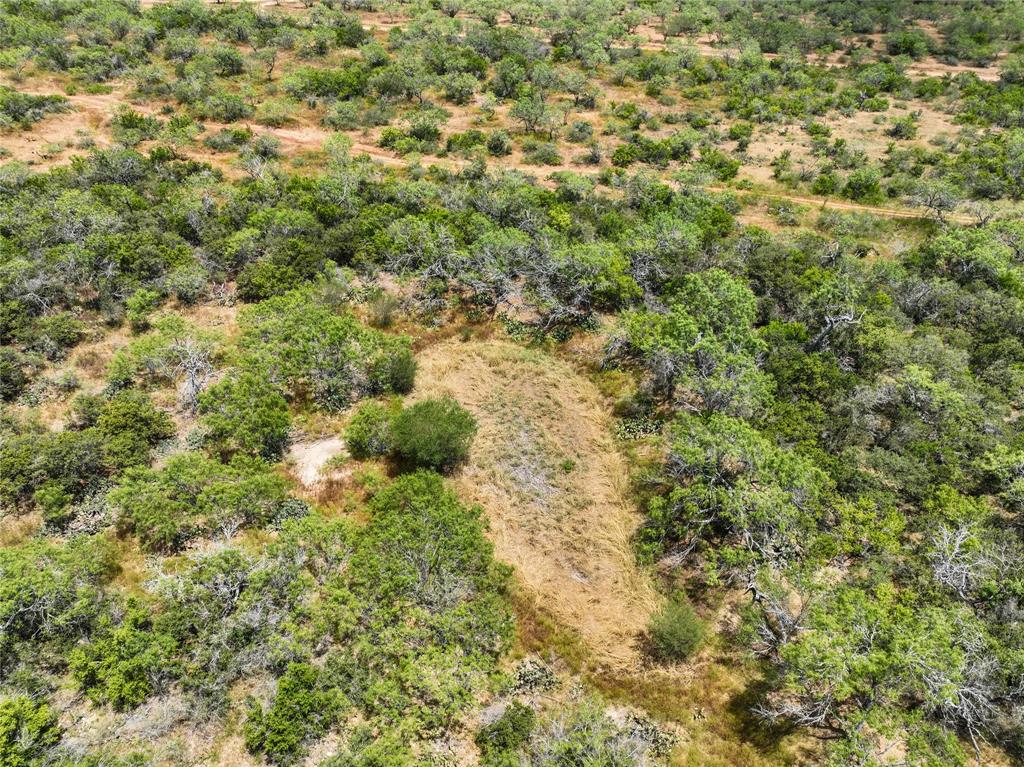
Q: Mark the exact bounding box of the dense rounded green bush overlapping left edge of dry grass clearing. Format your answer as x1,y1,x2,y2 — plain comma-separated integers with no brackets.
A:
392,397,476,472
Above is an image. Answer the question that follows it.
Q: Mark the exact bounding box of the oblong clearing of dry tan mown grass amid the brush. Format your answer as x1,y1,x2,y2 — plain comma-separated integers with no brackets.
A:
416,341,658,670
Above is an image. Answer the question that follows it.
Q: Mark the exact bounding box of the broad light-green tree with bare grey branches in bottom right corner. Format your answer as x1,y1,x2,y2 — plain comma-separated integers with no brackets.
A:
756,584,1005,764
